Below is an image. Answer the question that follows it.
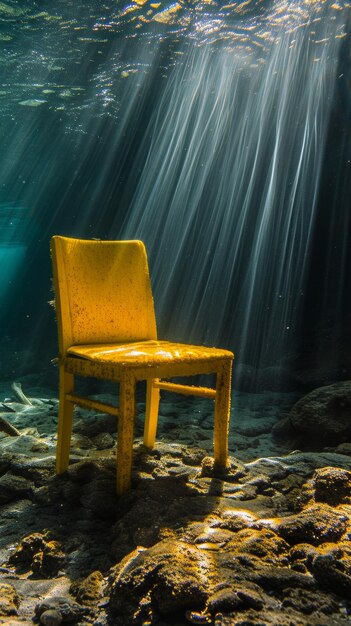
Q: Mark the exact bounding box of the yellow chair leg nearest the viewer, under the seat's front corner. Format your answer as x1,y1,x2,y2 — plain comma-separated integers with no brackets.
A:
116,372,135,496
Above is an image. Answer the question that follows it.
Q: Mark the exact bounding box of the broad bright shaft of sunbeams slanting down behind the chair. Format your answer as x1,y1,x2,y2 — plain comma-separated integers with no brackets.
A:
123,1,348,380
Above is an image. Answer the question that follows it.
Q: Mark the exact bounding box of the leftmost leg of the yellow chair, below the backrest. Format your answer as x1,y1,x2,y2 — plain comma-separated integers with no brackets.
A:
56,365,74,474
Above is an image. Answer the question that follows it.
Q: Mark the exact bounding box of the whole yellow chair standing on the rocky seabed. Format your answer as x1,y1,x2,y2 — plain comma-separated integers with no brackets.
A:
51,236,233,495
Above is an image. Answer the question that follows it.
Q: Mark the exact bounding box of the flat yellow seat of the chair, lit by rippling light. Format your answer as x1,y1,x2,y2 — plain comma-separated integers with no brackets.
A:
67,340,233,369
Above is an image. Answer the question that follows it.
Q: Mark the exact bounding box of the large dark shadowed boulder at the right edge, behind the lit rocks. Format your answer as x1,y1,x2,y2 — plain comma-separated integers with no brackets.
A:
273,381,351,448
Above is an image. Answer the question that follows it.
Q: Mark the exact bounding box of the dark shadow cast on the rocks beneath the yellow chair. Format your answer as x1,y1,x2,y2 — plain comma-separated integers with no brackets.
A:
0,445,234,579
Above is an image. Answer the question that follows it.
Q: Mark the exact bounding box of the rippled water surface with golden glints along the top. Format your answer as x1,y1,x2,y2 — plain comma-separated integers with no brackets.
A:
0,0,349,115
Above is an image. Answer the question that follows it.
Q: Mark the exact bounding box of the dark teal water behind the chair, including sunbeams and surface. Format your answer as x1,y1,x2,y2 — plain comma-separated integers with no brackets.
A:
0,0,351,385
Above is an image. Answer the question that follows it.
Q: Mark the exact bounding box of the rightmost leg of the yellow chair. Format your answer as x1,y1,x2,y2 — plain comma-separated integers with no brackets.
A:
214,361,232,467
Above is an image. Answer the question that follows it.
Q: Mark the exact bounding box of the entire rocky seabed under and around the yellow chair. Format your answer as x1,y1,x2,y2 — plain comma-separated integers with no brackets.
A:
0,382,351,626
